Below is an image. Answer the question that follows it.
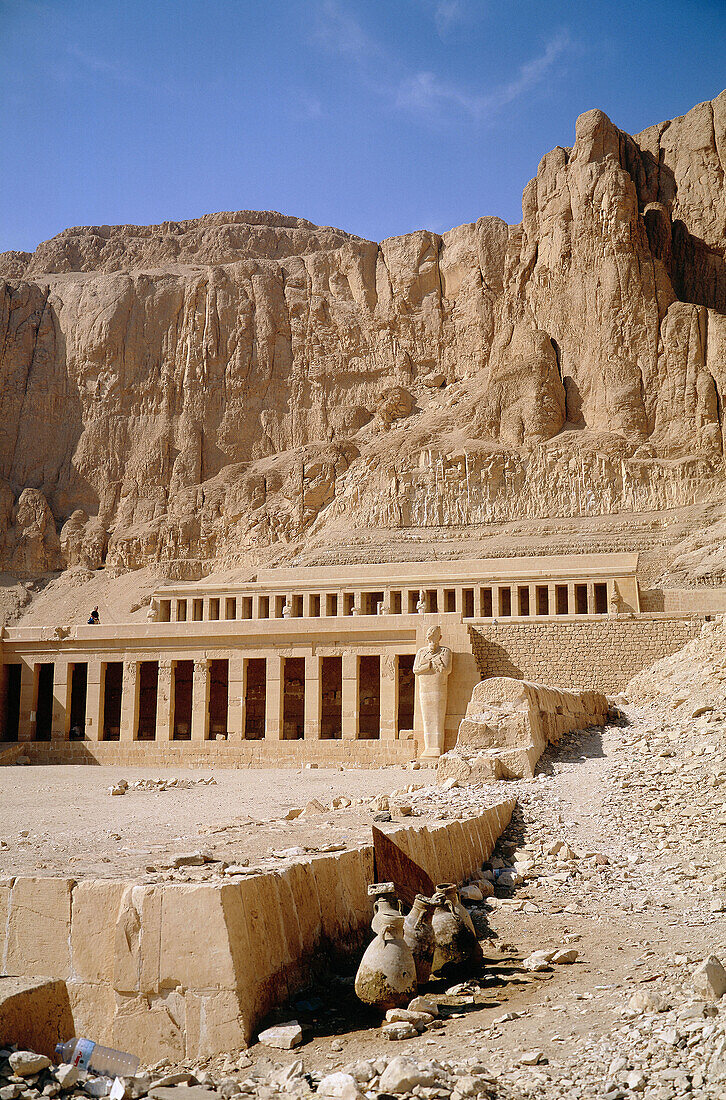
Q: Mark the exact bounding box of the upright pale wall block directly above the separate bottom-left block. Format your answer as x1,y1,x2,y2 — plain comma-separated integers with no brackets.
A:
4,878,74,980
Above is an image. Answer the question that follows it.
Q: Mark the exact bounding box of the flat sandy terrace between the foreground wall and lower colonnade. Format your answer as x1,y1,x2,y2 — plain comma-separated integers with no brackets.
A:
0,766,433,881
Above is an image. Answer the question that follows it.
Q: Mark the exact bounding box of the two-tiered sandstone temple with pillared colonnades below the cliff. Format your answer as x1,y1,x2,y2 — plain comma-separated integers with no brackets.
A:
0,554,639,744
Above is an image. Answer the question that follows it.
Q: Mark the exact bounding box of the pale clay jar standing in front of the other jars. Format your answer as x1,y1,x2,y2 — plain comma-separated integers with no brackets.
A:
355,912,416,1011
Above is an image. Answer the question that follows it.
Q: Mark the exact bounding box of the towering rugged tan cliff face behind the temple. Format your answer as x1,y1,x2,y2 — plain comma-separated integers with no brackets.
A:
0,92,726,576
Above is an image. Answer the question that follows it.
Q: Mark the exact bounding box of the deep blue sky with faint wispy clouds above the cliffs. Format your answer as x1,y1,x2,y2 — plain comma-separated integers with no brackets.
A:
0,0,726,251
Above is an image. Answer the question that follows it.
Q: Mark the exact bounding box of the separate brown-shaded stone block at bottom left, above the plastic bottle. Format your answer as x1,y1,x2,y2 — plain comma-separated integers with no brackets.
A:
0,978,75,1057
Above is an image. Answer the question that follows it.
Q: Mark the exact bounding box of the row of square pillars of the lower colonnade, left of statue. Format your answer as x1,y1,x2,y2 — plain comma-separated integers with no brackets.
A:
12,653,399,741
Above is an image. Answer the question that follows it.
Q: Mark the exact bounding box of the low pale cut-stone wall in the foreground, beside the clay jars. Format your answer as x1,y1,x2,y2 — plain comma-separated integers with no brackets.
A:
0,799,515,1063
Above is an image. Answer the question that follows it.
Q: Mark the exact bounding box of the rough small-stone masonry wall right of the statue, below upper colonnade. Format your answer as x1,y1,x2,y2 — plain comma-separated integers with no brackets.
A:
471,615,704,694
